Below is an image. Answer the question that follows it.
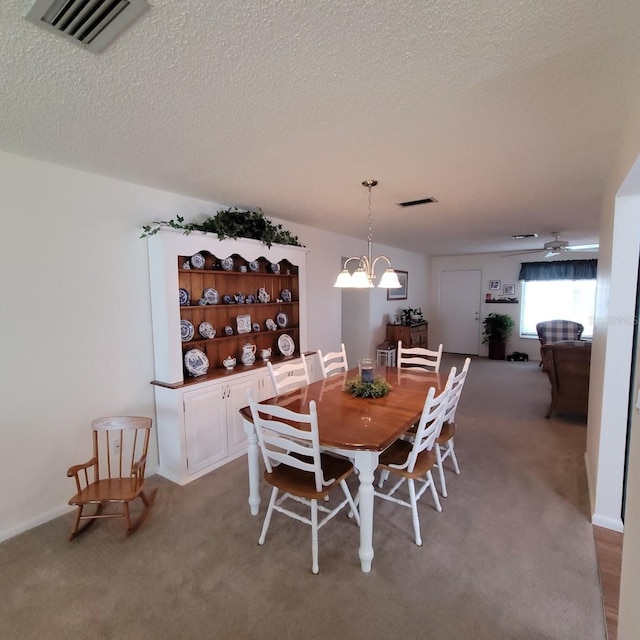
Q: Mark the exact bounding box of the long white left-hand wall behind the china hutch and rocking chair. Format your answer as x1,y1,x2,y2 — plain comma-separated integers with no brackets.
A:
0,152,426,540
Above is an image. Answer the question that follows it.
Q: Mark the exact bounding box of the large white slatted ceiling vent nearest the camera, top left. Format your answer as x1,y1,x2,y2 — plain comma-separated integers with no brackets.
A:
26,0,149,53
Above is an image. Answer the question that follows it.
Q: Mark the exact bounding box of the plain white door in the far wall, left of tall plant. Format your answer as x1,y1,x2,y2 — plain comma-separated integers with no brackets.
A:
440,269,482,356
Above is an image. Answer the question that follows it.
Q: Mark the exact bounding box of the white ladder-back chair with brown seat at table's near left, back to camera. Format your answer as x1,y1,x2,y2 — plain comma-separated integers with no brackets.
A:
249,394,360,573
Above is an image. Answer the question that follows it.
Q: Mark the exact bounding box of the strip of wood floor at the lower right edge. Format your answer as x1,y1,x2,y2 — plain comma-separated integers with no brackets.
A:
593,526,622,640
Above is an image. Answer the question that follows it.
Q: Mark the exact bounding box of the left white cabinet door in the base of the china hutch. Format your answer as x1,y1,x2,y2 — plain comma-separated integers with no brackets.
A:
184,384,228,475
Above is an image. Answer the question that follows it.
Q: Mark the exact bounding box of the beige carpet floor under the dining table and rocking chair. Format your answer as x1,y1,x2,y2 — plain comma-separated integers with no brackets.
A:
0,356,605,640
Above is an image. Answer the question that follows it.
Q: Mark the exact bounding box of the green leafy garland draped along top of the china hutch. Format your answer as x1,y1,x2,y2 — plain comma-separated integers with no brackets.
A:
140,207,303,247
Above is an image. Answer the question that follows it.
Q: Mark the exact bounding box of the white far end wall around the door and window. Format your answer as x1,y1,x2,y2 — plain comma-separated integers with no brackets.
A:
429,250,598,360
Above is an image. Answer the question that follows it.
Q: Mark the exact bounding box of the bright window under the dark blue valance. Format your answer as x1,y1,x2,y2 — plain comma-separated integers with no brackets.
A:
520,280,596,338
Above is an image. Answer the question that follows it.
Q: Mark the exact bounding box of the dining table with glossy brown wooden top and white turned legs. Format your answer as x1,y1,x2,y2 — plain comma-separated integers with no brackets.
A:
240,367,447,573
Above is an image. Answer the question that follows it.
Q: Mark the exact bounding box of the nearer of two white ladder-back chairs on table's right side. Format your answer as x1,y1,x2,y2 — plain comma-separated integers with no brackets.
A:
374,387,449,547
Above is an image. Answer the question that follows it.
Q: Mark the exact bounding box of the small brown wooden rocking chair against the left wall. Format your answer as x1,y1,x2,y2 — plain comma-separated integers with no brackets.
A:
67,416,156,540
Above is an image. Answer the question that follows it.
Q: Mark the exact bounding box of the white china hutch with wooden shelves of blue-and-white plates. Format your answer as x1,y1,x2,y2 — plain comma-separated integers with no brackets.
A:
148,228,311,485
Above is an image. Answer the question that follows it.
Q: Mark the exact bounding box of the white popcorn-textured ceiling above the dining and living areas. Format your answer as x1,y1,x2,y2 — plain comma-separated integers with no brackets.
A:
0,0,640,255
